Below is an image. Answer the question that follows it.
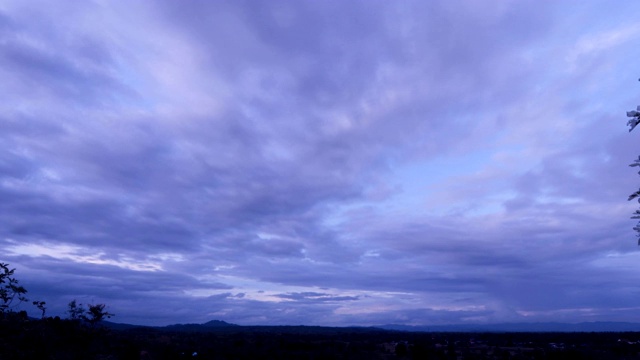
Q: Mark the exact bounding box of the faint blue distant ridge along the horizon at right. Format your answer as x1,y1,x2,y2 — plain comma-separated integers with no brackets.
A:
378,322,640,332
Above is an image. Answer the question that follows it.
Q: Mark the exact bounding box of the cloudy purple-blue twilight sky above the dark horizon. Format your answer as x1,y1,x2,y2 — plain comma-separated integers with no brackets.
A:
0,0,640,326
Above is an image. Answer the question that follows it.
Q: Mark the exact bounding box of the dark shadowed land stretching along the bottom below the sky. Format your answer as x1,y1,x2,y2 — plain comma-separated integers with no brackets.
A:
0,313,640,359
